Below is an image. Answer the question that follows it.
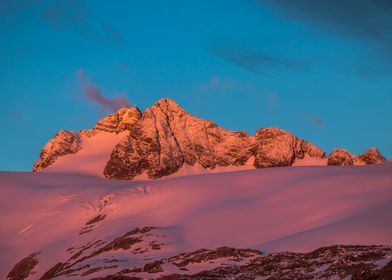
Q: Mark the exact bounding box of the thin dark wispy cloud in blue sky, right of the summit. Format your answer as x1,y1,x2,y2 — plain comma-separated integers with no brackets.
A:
212,45,302,77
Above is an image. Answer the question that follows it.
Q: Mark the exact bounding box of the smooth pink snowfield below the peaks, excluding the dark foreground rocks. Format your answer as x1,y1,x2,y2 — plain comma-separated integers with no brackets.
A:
0,163,392,279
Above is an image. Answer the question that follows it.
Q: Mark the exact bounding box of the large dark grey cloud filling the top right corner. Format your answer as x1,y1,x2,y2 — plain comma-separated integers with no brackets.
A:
257,0,392,59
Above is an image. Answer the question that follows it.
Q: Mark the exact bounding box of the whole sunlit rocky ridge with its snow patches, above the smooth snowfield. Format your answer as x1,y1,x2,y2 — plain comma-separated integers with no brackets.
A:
33,98,385,180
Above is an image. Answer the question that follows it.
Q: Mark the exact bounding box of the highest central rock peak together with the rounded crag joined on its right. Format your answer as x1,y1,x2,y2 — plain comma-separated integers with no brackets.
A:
104,99,325,179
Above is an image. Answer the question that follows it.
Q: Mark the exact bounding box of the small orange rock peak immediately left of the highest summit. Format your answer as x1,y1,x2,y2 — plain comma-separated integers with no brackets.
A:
94,107,142,133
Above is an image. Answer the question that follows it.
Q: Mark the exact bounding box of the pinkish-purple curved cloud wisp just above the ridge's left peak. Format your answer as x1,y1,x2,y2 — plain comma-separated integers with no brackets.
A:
77,70,133,111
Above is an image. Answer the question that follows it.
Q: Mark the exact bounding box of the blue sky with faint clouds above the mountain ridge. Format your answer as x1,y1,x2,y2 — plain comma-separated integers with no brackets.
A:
0,0,392,170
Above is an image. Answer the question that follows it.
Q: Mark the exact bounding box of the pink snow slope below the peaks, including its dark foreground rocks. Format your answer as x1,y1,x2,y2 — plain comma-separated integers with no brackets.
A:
0,162,392,279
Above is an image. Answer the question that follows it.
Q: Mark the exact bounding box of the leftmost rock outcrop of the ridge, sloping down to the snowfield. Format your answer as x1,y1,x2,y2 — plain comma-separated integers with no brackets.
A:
33,130,81,172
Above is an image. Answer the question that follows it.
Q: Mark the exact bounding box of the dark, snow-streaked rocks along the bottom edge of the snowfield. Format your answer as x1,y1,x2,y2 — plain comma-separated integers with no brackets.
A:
7,227,392,280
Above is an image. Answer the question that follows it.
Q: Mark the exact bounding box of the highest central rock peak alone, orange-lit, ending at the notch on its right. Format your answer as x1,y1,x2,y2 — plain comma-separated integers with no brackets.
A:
104,99,256,179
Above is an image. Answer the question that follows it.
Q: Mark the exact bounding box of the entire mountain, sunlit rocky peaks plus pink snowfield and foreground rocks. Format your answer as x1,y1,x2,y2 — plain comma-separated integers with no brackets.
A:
0,99,392,280
